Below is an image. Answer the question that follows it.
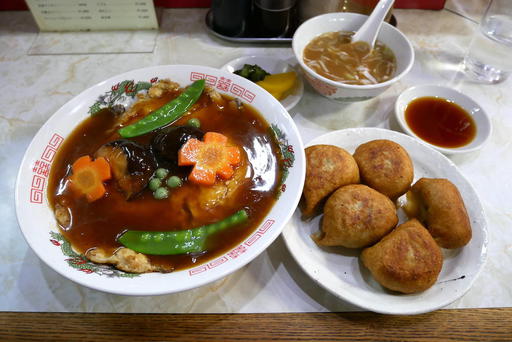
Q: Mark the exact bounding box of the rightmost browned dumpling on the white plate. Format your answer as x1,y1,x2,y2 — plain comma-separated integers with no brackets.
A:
404,178,472,248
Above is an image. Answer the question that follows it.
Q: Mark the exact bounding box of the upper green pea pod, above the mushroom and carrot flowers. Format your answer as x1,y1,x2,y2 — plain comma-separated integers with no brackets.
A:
118,79,205,138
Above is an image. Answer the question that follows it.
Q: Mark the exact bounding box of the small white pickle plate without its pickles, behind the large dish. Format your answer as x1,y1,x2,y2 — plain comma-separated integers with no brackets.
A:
222,56,304,110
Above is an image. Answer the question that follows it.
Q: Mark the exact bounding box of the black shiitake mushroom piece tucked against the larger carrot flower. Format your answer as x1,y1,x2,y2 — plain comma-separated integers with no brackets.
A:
151,126,204,174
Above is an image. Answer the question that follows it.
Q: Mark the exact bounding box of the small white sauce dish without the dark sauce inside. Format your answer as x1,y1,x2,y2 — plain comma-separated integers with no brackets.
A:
395,85,492,154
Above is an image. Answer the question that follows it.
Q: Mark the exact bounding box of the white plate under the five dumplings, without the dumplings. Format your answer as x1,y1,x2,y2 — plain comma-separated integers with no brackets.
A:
283,128,487,314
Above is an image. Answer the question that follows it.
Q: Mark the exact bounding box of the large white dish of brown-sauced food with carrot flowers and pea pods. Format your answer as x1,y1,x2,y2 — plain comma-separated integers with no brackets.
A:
15,65,305,295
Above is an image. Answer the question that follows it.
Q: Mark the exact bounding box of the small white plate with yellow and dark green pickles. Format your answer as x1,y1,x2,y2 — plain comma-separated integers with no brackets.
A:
221,56,304,111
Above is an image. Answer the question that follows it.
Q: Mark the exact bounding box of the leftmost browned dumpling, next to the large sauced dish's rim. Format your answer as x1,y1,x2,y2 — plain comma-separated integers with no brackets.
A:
300,145,359,219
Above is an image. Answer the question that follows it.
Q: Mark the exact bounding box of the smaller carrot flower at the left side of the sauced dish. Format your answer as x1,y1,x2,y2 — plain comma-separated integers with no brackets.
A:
69,156,112,202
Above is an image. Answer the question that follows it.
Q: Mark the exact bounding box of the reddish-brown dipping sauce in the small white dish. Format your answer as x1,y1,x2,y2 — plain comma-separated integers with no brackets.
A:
405,96,476,148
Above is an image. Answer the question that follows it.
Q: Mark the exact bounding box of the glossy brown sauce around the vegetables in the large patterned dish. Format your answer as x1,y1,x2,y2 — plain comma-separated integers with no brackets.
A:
48,94,280,270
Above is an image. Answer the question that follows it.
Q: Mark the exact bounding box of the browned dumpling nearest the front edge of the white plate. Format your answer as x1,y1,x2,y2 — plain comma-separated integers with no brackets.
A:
361,219,443,293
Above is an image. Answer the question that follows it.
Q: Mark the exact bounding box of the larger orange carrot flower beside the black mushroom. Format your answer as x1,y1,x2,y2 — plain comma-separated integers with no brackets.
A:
178,132,241,185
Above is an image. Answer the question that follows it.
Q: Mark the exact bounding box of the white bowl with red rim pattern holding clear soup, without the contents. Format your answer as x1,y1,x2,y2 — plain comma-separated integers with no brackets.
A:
292,12,414,101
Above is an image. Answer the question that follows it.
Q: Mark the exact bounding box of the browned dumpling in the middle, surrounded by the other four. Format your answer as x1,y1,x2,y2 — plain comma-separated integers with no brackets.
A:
313,184,398,248
